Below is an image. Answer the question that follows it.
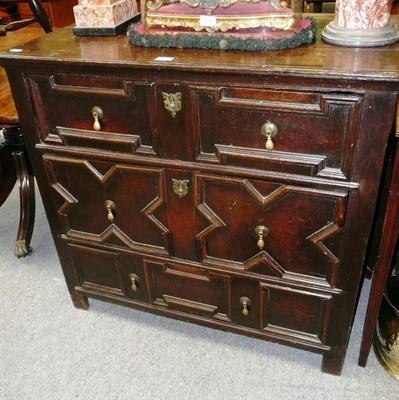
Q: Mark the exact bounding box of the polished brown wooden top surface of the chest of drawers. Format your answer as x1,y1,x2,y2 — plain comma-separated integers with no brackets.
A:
0,14,399,82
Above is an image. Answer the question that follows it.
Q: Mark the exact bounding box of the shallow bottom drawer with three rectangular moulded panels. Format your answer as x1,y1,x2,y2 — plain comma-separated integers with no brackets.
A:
69,244,333,346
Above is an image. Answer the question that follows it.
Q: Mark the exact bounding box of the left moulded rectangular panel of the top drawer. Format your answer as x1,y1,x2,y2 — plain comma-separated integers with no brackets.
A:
29,74,155,155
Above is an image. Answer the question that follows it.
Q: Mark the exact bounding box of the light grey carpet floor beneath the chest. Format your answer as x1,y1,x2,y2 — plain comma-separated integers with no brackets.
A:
0,185,399,400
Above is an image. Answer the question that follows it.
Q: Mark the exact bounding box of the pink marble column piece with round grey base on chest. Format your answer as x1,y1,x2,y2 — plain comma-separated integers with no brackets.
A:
322,0,399,47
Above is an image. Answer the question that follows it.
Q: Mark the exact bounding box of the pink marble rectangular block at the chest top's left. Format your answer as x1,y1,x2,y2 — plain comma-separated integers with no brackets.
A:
73,0,137,28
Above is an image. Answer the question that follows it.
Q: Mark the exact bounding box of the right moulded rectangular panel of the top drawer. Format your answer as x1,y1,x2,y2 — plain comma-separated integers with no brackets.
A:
192,87,363,179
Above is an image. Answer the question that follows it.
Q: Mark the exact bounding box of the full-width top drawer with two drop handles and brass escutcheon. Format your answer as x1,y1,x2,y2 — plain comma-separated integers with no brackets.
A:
30,74,363,180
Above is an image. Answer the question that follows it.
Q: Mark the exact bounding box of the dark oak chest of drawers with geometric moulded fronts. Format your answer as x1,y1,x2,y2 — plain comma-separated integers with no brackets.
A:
0,16,399,374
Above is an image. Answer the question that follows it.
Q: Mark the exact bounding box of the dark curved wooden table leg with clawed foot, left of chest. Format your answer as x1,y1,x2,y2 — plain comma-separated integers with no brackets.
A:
4,126,35,258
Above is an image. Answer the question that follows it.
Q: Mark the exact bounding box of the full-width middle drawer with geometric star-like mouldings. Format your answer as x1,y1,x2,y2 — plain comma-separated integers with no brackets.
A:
43,155,348,287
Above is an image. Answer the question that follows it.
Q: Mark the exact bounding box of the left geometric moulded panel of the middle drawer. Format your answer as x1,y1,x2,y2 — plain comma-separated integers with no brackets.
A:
43,155,169,254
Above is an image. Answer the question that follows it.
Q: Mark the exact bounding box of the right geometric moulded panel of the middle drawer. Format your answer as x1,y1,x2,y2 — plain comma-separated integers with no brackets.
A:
195,174,348,287
